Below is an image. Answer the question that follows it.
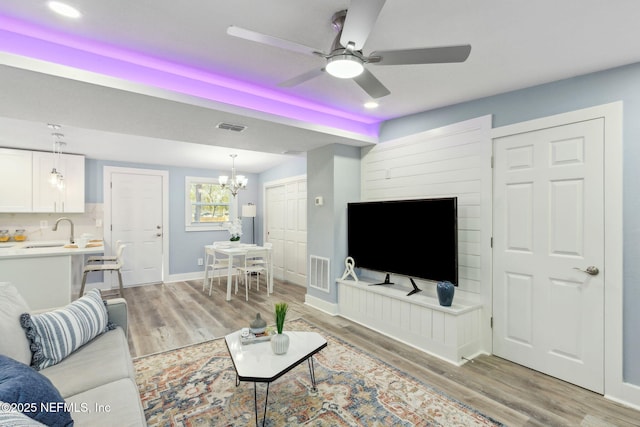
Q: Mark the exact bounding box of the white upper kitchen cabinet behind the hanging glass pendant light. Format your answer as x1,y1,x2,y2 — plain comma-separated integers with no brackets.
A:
32,152,84,212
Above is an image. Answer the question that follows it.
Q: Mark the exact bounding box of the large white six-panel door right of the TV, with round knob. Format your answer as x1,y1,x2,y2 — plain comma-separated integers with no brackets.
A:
493,119,605,393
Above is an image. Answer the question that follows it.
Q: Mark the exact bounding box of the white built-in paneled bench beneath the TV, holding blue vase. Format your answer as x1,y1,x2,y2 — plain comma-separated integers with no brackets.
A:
337,279,482,366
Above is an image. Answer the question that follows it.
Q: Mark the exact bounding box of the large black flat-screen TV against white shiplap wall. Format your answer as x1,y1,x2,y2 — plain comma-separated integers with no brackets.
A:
347,197,458,286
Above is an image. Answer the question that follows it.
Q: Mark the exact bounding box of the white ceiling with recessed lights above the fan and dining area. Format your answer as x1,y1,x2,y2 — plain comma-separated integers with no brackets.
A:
0,0,640,172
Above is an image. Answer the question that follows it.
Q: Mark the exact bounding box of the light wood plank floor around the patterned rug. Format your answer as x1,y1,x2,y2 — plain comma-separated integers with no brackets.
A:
115,281,640,427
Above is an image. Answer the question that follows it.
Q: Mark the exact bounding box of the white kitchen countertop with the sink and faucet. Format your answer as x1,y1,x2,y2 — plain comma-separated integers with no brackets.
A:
0,240,104,260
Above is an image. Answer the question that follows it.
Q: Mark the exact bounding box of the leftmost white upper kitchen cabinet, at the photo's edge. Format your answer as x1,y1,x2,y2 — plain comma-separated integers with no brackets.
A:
0,148,33,212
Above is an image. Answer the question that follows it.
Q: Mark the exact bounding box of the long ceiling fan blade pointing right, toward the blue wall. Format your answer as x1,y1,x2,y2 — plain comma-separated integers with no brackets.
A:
370,44,471,65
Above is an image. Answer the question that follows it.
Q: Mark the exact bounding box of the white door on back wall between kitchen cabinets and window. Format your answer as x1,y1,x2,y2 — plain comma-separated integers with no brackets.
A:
110,172,164,286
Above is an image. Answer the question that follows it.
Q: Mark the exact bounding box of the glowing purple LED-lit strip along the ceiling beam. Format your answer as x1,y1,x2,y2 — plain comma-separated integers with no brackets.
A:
0,15,379,137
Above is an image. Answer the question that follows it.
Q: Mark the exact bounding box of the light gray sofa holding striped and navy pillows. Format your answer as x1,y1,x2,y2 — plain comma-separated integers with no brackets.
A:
0,283,146,426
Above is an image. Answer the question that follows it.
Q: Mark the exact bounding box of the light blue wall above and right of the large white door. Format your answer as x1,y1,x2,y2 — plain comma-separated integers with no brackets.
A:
380,64,640,385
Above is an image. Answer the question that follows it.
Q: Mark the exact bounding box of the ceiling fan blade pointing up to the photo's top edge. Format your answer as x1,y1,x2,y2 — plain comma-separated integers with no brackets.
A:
340,0,386,50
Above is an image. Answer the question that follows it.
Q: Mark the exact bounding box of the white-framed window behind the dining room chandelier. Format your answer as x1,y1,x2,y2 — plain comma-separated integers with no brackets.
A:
185,176,237,231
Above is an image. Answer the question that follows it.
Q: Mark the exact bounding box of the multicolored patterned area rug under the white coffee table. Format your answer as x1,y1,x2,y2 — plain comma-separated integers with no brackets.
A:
134,319,501,427
